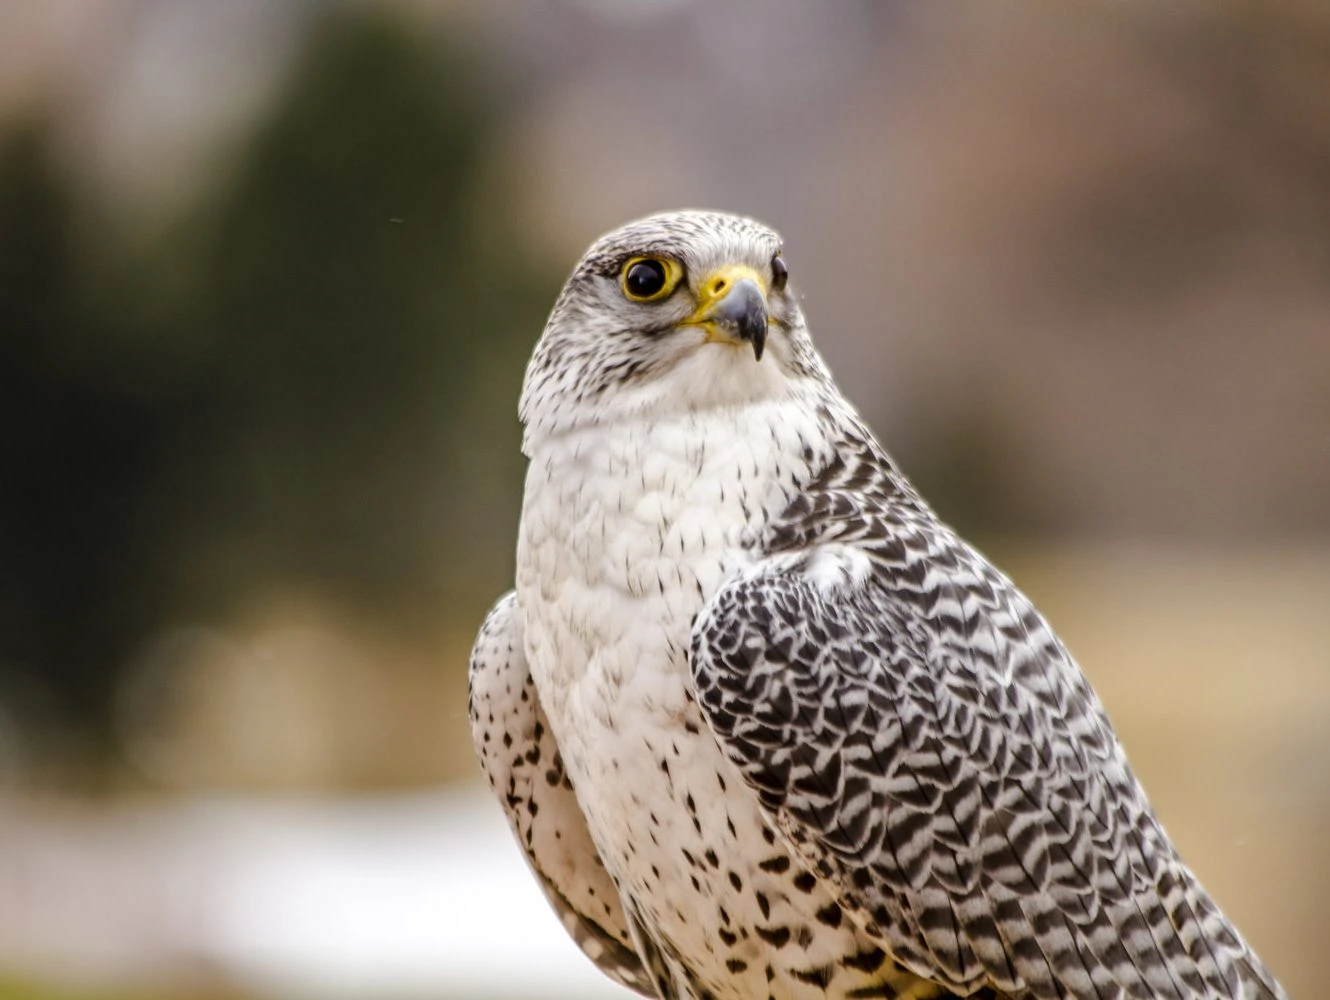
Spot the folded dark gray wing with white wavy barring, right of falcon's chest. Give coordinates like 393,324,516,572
692,449,1285,1000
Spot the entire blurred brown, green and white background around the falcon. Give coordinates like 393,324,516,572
0,0,1330,1000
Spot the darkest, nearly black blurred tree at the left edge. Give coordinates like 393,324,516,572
0,121,179,765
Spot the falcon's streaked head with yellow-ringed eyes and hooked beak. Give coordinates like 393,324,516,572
520,211,826,443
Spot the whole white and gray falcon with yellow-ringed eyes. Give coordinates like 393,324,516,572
469,210,1286,1000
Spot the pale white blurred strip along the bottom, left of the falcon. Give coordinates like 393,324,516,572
0,789,630,1000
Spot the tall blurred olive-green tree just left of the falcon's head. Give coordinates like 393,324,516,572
156,11,549,622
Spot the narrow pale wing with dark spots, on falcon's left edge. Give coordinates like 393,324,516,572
469,592,656,997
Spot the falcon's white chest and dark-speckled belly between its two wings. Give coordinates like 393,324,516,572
517,402,938,997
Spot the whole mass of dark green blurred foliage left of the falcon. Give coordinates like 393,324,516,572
0,9,559,771
